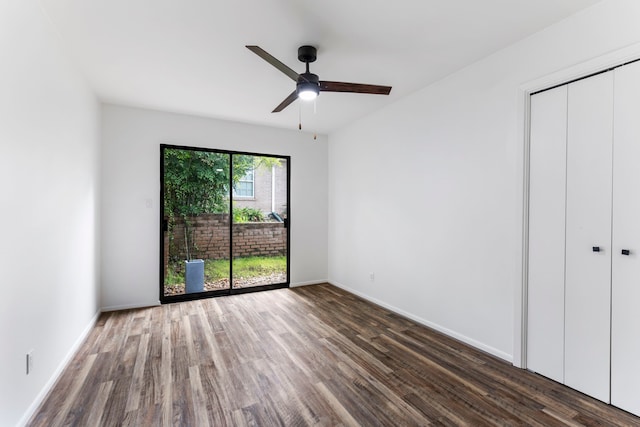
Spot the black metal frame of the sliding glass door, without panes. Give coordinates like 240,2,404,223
158,144,291,304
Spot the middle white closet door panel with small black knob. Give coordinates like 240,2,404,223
564,72,613,402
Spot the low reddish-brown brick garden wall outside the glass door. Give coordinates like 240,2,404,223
165,214,287,265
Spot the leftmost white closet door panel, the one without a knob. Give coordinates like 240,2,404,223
527,85,567,382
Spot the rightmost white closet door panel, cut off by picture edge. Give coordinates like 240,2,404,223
611,63,640,415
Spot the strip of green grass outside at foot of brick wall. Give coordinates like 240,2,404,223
164,256,287,285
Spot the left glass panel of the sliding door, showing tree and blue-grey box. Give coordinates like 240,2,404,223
161,146,231,297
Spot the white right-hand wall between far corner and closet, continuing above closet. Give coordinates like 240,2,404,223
329,0,640,360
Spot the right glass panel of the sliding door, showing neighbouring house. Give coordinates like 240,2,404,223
231,154,288,289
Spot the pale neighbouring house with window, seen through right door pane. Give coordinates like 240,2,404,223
233,159,287,217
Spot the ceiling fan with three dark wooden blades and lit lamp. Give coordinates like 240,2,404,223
246,46,391,113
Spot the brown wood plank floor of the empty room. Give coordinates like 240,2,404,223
29,284,640,426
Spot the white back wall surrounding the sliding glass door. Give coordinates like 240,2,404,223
102,105,327,309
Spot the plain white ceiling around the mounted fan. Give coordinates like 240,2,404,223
40,0,599,133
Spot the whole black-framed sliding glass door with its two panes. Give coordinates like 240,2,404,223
160,145,290,302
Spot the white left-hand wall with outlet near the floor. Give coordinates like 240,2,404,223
0,0,99,426
